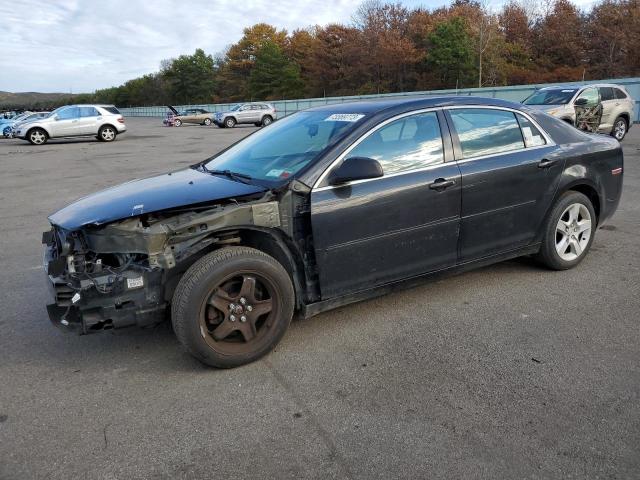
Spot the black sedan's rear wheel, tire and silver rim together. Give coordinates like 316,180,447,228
537,190,597,270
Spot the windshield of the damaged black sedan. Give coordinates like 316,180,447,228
205,111,364,186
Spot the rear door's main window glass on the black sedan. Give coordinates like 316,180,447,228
449,108,524,158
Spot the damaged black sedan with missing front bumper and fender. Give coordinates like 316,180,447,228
43,97,623,367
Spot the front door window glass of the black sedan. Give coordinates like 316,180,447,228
348,112,444,175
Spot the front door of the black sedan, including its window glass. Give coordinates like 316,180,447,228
311,111,460,299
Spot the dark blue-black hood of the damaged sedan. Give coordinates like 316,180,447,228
49,168,266,230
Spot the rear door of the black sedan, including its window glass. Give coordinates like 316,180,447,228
447,107,563,263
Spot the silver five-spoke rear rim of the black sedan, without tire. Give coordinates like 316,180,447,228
555,203,592,261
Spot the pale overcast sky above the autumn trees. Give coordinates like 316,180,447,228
0,0,590,93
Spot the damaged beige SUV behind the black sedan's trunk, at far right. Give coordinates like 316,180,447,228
523,83,636,140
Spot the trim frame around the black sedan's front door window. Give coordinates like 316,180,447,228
313,107,451,192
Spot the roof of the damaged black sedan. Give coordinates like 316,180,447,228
307,95,529,114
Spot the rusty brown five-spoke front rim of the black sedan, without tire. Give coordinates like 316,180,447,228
199,272,278,354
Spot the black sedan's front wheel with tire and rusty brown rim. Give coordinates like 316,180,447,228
171,247,295,368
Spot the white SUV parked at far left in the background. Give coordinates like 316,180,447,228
13,105,127,145
